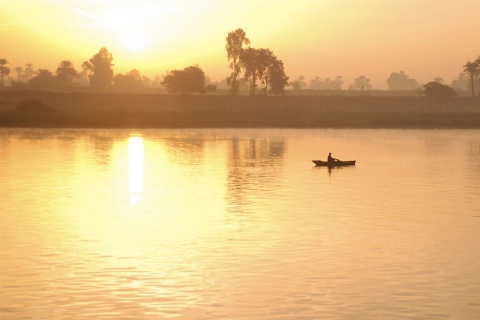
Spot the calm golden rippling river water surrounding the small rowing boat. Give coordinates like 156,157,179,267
0,129,480,320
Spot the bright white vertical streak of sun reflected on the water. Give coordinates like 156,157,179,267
128,135,144,204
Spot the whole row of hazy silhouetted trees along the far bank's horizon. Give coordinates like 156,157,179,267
0,28,480,96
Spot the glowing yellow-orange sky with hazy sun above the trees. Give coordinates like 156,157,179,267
0,0,480,89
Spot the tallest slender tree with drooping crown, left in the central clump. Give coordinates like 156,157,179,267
225,28,250,95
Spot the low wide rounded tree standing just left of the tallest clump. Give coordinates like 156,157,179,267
162,65,205,94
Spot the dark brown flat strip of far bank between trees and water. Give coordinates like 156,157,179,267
0,90,480,128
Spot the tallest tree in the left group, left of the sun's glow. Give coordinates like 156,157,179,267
82,48,113,90
